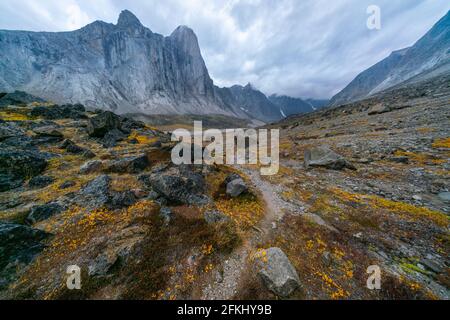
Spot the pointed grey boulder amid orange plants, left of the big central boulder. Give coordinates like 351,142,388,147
73,175,111,209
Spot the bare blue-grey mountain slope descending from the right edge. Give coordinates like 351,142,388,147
331,11,450,106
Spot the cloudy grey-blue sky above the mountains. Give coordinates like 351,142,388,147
0,0,450,99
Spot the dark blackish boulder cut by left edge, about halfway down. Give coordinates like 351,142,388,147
0,148,47,191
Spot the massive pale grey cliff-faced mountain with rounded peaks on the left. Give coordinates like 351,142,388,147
0,10,282,121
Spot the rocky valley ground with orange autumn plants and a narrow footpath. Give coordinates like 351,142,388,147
0,72,450,299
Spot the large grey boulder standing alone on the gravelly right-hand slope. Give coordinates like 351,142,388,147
304,146,356,170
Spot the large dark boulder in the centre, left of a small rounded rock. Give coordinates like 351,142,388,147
149,167,210,205
